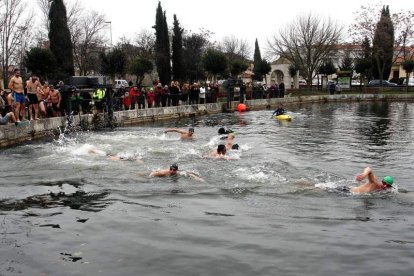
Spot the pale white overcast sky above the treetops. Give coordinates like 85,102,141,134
79,0,392,51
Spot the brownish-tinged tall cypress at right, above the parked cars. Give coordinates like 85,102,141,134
372,6,394,80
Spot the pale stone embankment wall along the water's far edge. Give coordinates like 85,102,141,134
0,94,414,148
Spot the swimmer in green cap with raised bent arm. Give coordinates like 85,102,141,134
351,167,394,194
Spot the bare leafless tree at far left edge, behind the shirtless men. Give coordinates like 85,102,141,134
0,0,33,87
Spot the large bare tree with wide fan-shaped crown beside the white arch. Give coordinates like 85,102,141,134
267,13,342,85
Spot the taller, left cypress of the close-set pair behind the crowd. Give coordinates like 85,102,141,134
154,2,171,84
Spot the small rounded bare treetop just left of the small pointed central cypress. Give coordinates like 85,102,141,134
219,35,252,59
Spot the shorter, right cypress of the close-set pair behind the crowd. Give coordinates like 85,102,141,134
172,14,185,81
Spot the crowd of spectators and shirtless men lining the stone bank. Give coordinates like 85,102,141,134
0,69,285,124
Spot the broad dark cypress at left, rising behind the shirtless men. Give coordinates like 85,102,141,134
49,0,75,81
